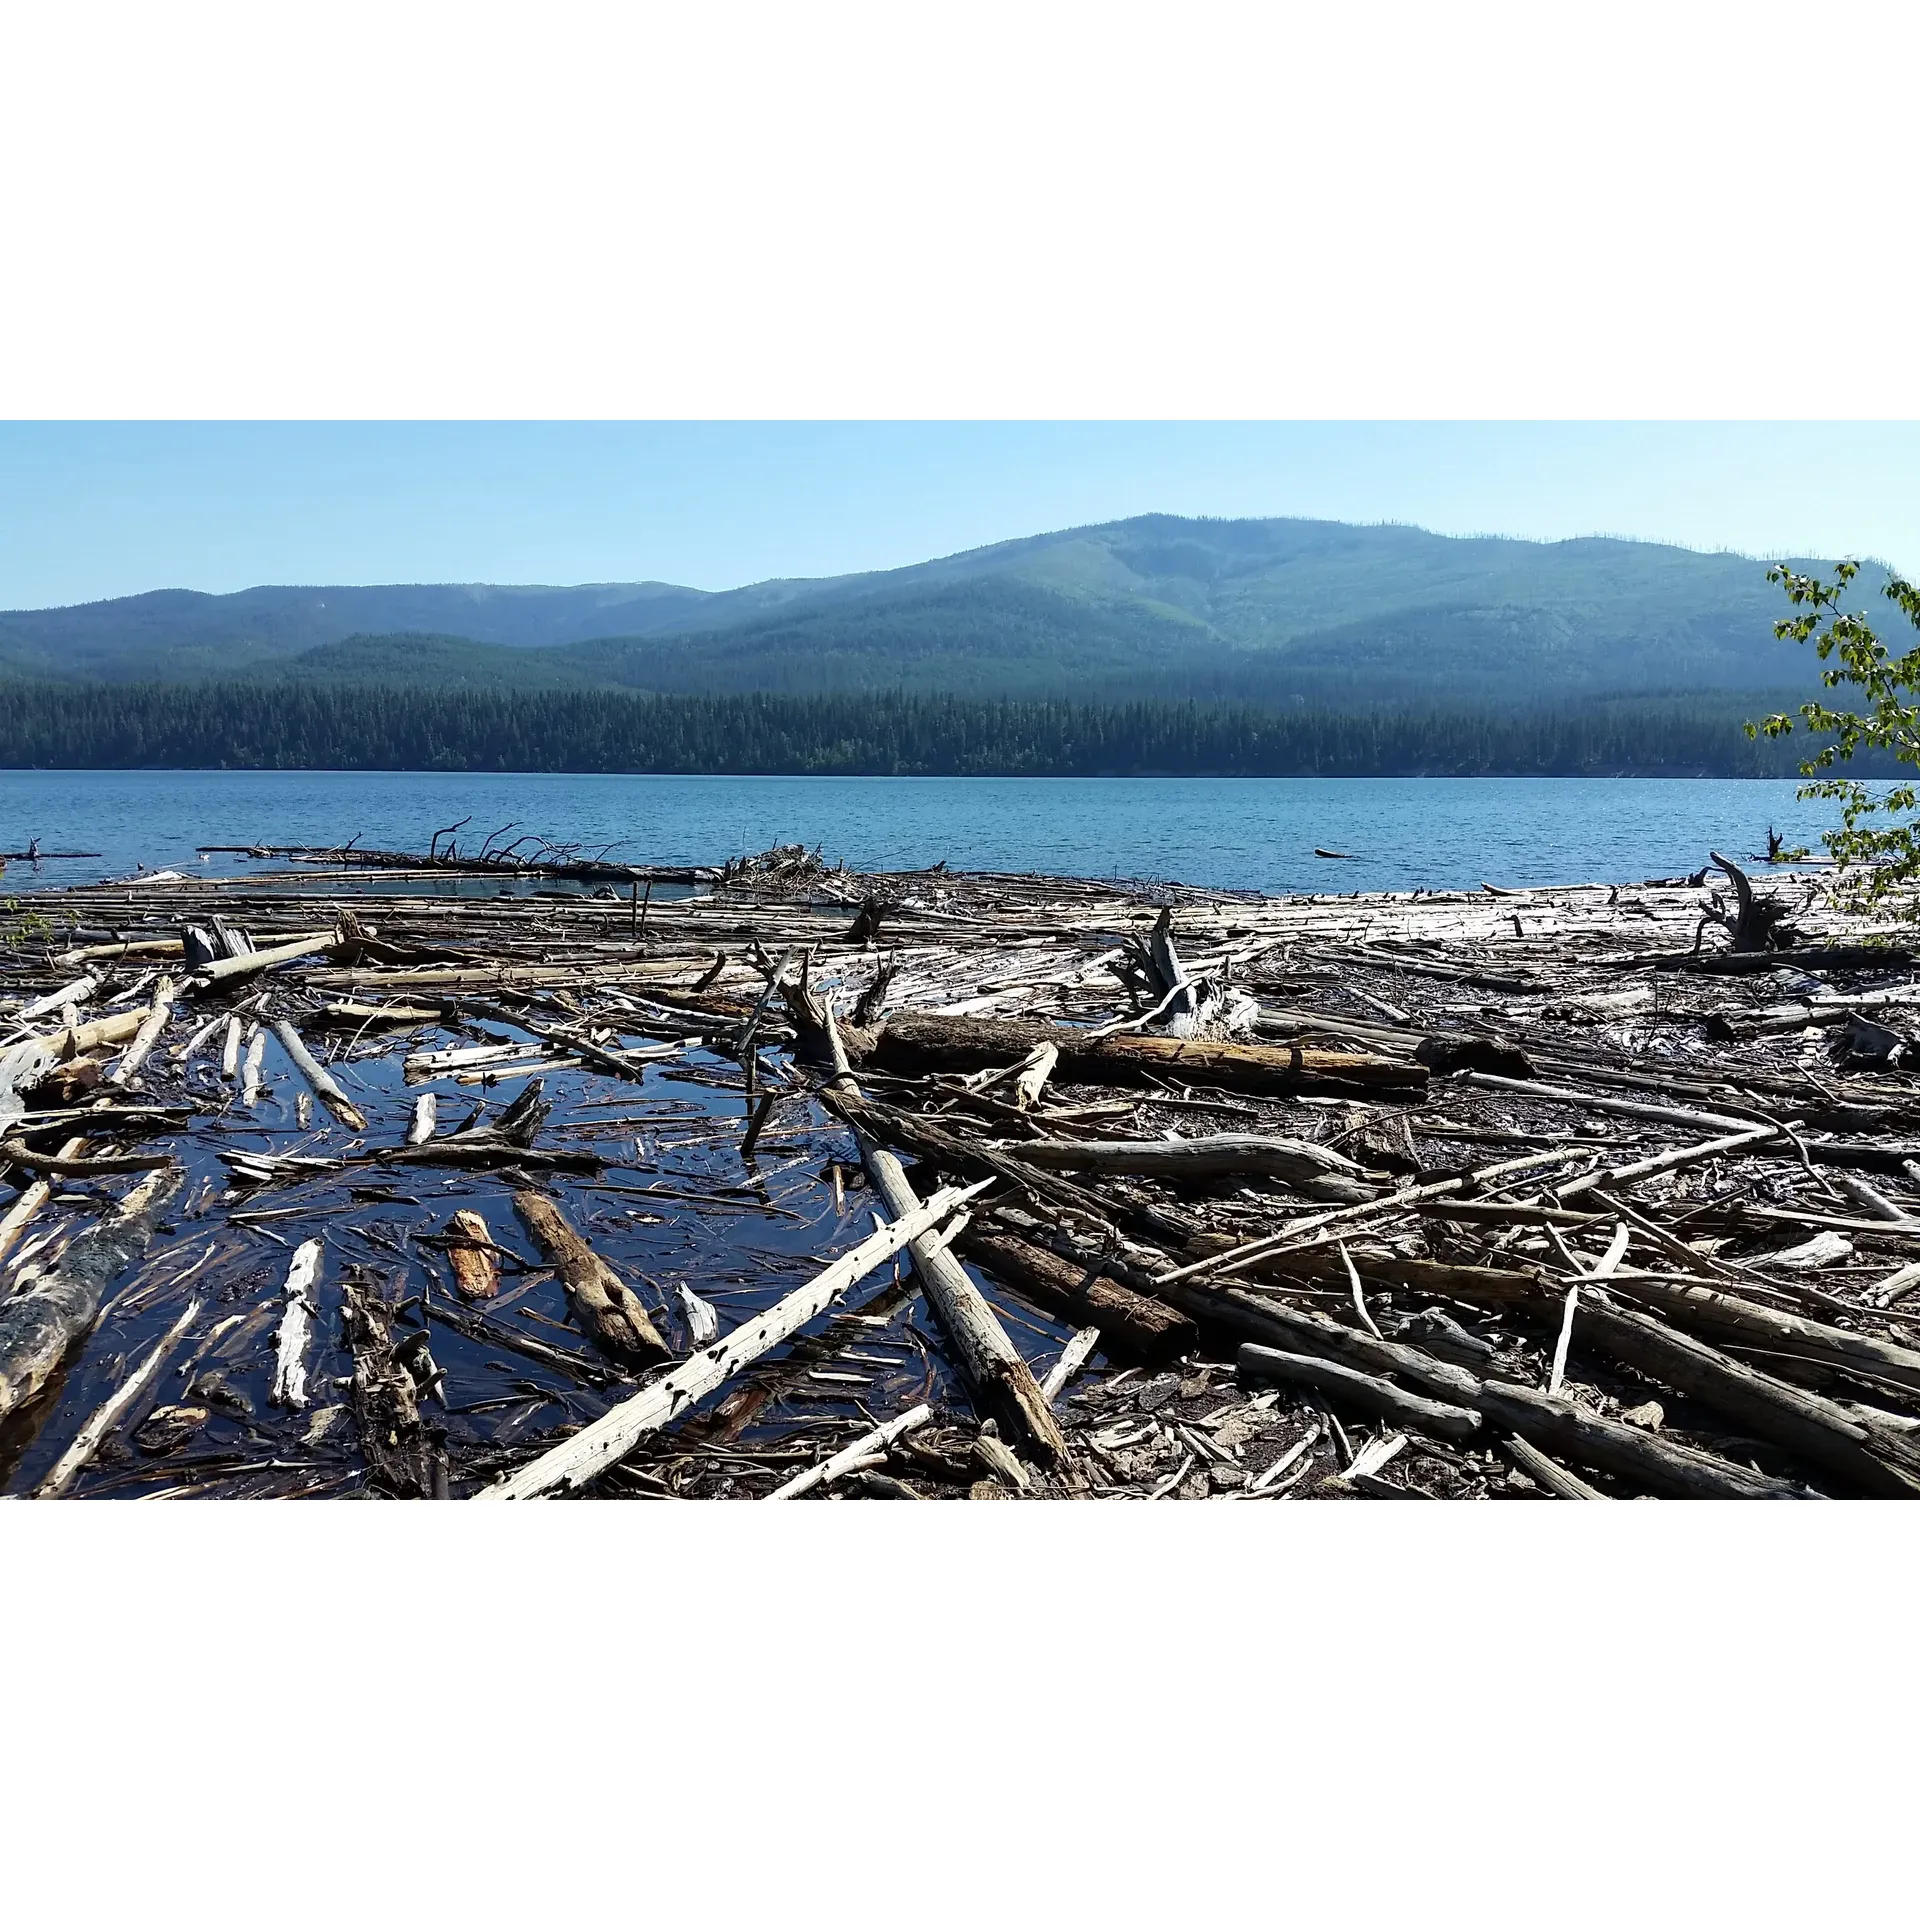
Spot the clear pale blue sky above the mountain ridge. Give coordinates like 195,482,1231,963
0,422,1920,607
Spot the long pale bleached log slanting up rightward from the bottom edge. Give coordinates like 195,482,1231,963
474,1183,985,1500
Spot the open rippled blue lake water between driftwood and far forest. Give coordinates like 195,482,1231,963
0,772,1837,893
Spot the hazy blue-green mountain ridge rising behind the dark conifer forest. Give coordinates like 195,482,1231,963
0,515,1878,705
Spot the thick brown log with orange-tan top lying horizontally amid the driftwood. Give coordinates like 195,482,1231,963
845,1014,1427,1098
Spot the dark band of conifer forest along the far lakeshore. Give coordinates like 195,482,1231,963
0,682,1812,778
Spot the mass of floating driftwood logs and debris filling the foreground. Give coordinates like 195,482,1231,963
0,843,1920,1500
